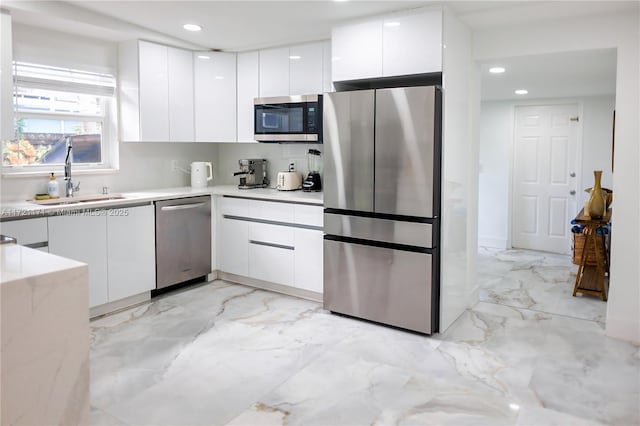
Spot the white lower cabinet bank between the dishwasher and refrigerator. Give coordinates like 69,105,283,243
218,197,323,293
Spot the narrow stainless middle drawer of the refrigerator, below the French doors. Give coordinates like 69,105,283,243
324,213,437,248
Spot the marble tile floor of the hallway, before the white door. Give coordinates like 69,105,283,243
478,247,607,323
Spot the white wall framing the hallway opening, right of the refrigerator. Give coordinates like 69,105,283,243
474,12,640,342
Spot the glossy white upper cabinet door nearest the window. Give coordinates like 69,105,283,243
138,41,169,142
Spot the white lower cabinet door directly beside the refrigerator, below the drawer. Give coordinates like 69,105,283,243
294,229,323,293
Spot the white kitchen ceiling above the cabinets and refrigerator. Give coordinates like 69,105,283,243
3,0,638,51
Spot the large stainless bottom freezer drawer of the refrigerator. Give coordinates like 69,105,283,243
324,239,433,333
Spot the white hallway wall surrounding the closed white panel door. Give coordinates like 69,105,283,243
478,96,615,248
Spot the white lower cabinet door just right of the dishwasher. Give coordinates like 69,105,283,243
218,218,249,277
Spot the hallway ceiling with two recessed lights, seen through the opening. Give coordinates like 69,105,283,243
481,49,616,101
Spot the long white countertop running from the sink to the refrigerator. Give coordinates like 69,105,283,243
0,185,323,219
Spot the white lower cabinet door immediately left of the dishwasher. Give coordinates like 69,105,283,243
107,205,156,302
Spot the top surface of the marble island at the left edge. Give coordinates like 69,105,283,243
0,244,84,285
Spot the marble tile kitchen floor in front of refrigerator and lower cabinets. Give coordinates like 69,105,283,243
91,281,640,426
